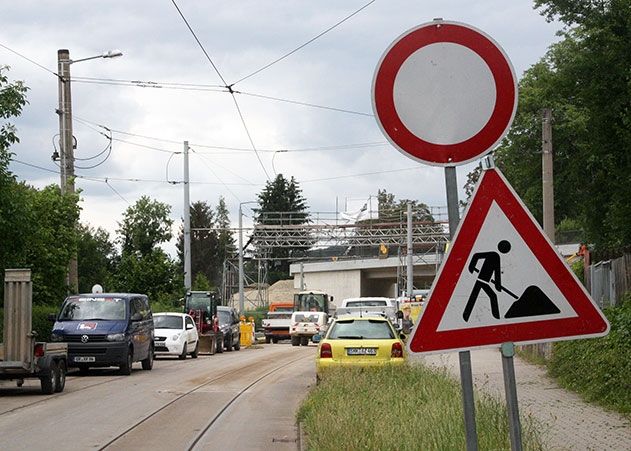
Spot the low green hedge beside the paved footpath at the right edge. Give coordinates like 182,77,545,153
548,293,631,415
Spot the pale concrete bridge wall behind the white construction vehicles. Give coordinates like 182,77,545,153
294,269,361,306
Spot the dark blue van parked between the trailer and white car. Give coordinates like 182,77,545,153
51,293,153,375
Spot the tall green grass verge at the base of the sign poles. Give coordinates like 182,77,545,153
298,365,543,451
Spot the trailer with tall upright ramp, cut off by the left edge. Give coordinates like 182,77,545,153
0,269,68,395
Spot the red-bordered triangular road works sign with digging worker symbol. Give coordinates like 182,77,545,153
408,169,609,353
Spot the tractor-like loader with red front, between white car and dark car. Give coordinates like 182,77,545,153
184,291,223,355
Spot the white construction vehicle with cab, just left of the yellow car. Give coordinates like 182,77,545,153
289,291,336,346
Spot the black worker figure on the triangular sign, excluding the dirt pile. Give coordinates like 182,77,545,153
462,240,511,321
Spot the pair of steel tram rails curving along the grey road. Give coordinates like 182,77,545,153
97,355,313,451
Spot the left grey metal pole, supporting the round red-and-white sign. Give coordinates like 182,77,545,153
445,166,478,451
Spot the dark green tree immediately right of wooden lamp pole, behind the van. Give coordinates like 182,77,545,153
77,224,118,293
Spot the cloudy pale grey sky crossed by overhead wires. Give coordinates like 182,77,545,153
0,0,560,251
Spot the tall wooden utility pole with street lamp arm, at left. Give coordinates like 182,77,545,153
57,49,123,291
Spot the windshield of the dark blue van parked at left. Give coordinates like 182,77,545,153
59,297,126,321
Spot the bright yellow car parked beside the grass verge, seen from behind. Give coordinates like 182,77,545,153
316,316,405,378
